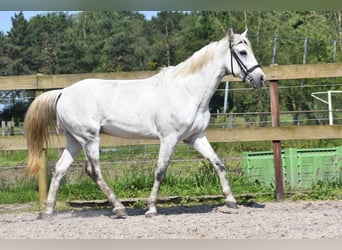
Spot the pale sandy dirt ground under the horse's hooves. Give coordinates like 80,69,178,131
0,201,342,239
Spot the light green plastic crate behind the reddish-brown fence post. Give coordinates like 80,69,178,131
242,147,342,189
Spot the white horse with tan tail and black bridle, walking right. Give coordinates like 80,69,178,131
25,29,266,217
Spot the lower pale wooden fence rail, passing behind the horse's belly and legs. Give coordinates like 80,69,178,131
0,125,342,151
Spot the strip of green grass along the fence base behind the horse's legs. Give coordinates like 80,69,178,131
0,157,342,206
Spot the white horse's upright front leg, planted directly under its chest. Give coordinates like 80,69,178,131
145,138,177,217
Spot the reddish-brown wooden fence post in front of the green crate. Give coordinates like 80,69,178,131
270,80,284,201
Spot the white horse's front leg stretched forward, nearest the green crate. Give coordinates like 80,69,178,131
184,134,237,208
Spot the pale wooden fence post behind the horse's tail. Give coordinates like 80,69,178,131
36,90,47,209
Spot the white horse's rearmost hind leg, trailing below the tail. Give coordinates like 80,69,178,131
41,133,82,218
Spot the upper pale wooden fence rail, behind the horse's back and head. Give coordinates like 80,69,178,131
0,63,342,90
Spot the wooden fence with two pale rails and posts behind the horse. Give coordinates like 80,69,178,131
0,63,342,207
